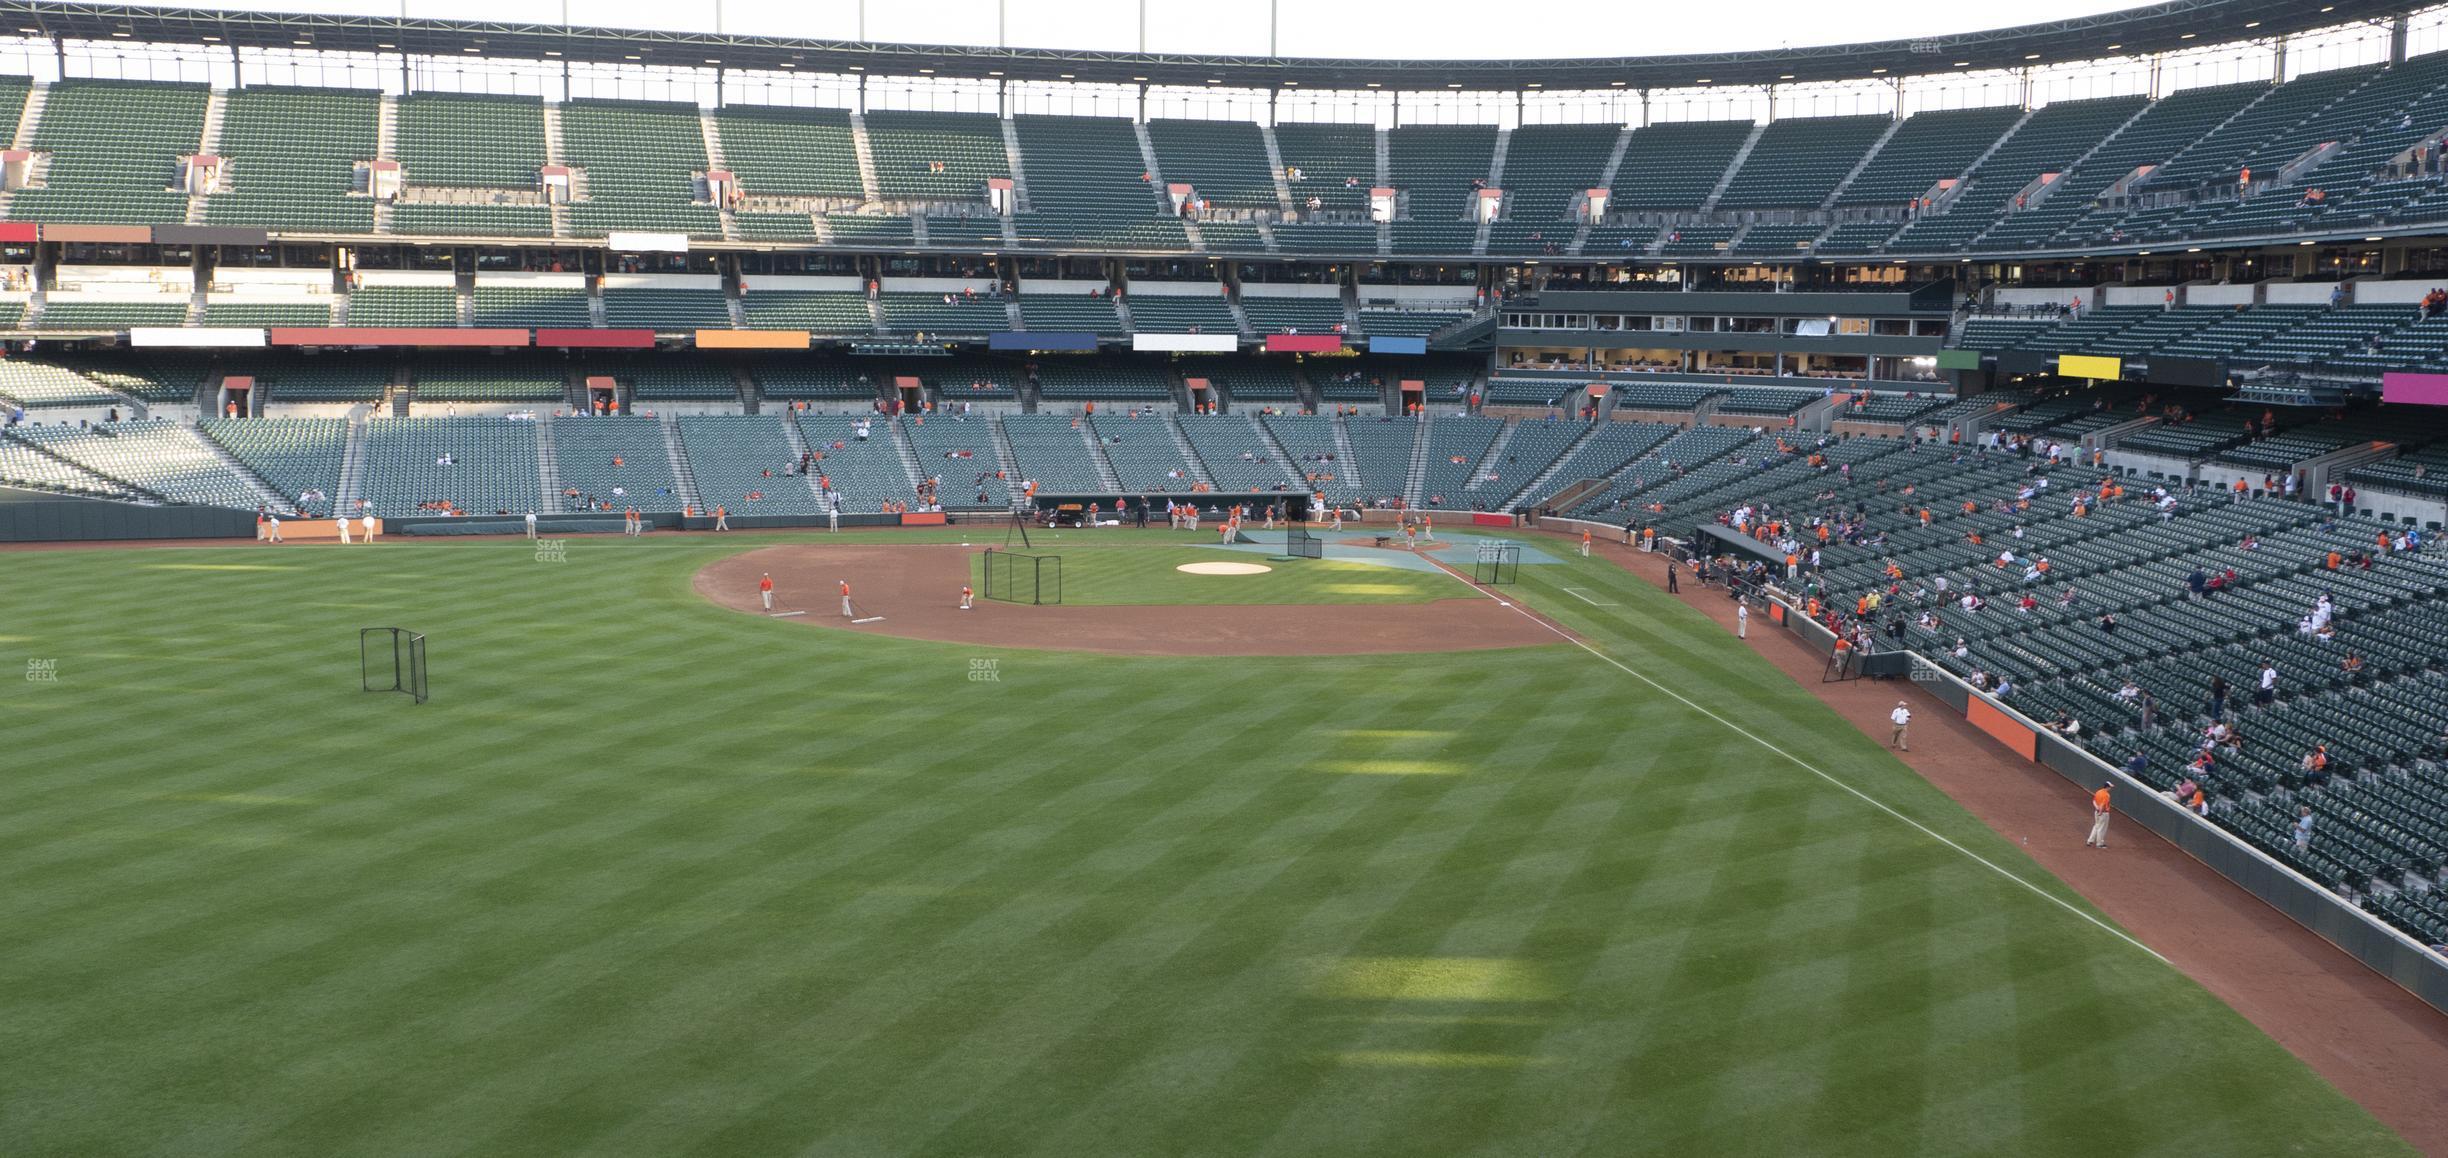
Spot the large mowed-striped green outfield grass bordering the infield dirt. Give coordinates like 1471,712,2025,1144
0,536,2404,1156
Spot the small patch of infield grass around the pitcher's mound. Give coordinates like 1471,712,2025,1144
969,534,1471,607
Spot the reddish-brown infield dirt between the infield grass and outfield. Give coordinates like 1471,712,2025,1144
693,544,1569,656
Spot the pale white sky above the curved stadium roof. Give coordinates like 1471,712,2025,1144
137,0,2140,59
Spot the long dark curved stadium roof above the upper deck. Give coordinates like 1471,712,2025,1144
0,0,2424,91
